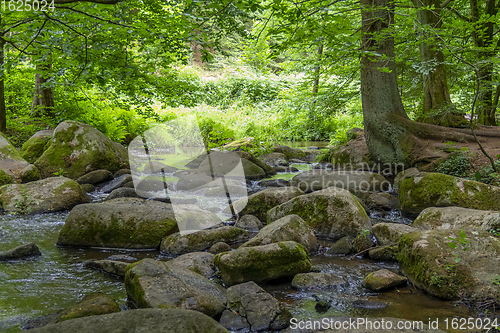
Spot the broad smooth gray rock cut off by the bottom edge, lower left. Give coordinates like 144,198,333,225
23,309,227,333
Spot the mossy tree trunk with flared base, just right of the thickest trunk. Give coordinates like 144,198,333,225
413,0,467,127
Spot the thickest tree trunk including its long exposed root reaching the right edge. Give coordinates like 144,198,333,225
361,0,500,167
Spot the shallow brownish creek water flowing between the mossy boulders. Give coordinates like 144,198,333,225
0,160,498,333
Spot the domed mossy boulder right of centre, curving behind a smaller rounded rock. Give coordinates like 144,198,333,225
267,187,371,240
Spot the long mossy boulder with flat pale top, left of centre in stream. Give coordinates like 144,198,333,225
57,198,178,249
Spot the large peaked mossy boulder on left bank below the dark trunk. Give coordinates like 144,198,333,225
34,121,128,179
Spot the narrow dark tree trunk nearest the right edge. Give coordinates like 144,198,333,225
470,0,498,125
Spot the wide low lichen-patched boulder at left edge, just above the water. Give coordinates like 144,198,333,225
0,177,90,214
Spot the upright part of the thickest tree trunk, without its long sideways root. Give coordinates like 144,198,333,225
361,0,409,164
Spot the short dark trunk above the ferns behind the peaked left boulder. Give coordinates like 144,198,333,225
31,64,54,118
